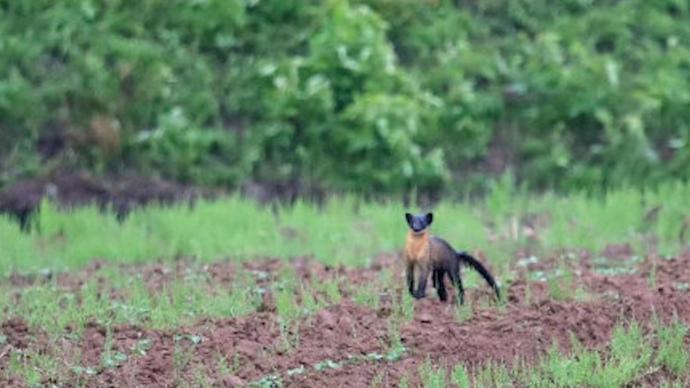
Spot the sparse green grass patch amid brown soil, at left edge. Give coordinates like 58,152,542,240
0,270,259,335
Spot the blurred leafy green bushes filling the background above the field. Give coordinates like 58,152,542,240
0,0,690,193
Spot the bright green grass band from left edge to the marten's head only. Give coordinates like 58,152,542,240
0,197,406,275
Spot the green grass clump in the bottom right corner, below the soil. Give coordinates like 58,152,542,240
440,322,688,388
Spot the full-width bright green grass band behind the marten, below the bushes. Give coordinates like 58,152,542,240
0,183,690,275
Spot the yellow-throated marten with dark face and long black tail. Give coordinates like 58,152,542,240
405,213,500,304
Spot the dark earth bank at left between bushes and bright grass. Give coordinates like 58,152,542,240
0,168,336,230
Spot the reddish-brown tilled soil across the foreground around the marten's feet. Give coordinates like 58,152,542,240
0,252,690,387
